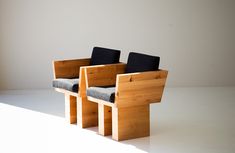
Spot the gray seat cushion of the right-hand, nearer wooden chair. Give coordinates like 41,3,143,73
87,87,115,103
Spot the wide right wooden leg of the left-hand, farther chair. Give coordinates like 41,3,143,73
77,97,98,128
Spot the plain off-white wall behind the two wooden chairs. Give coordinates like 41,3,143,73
0,0,235,89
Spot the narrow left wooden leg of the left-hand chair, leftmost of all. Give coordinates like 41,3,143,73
65,94,77,124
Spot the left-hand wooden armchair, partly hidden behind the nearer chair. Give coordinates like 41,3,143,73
53,47,120,127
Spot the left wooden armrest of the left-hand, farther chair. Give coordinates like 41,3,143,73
53,58,90,79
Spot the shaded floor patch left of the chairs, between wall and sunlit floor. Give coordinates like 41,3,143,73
0,90,64,117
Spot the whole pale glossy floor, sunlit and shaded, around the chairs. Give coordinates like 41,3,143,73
0,87,235,153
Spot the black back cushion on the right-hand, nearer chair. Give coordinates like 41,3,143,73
126,52,160,73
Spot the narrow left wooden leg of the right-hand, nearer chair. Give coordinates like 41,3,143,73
98,104,112,136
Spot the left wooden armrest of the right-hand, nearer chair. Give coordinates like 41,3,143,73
85,63,126,87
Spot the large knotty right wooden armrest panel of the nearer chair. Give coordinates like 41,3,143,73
115,70,168,107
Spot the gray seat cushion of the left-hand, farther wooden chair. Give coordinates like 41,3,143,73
52,78,79,92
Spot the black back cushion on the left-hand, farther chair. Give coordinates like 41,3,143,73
90,47,121,65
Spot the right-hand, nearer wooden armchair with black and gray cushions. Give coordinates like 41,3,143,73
84,52,168,141
